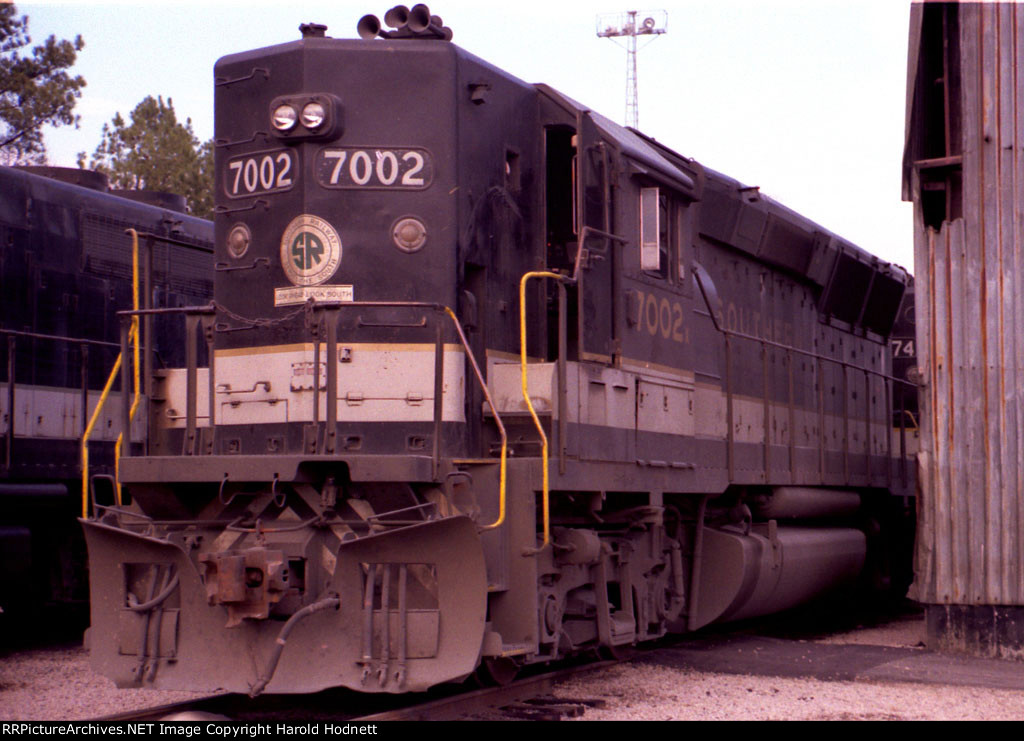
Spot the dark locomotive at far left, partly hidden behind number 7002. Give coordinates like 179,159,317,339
0,167,213,627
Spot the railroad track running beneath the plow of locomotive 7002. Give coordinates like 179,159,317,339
95,658,626,723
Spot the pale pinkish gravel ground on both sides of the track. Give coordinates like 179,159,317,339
0,618,1024,721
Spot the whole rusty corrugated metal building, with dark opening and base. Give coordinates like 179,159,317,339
903,2,1024,657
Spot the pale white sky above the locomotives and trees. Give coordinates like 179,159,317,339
17,0,913,269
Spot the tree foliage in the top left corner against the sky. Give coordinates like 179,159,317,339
0,3,85,162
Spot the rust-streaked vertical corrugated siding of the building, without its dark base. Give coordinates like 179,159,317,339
913,3,1024,605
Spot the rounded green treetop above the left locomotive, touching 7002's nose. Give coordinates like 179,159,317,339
86,95,213,218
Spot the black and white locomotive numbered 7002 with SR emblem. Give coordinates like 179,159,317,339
77,5,913,695
